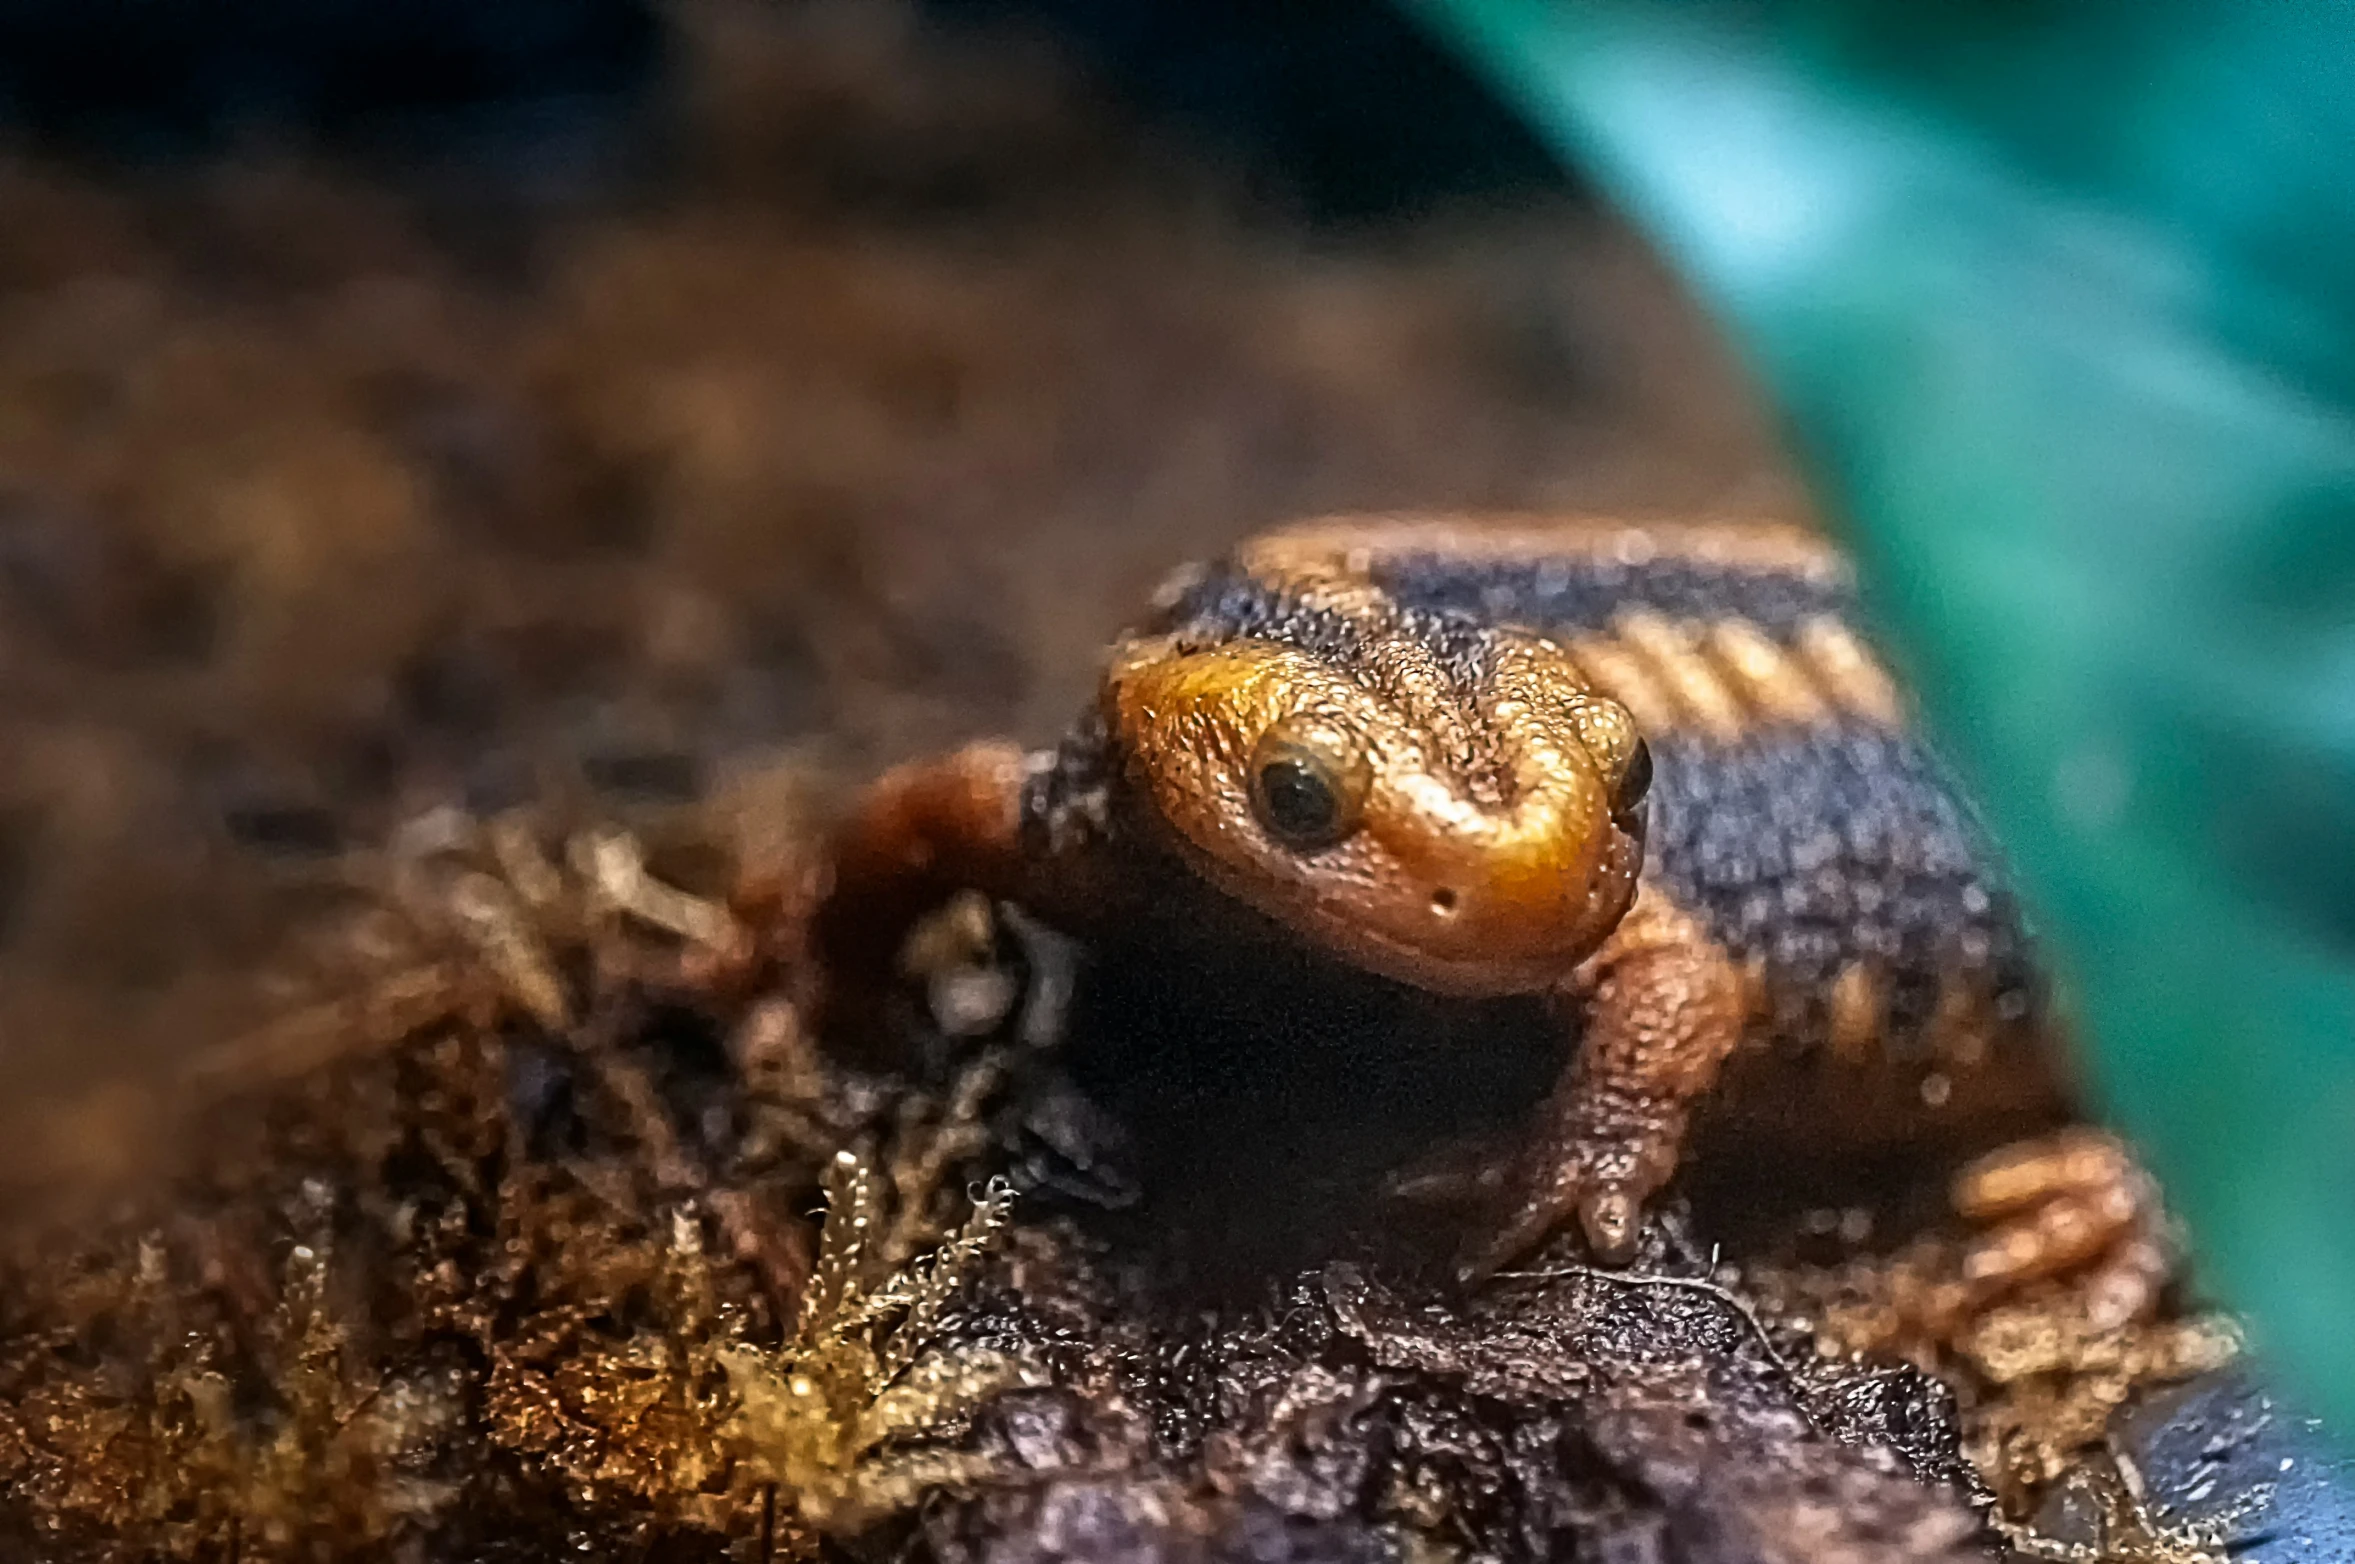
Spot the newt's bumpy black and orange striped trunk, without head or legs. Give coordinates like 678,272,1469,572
1022,525,2051,1116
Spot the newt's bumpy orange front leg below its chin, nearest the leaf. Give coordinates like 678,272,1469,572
1462,886,1745,1279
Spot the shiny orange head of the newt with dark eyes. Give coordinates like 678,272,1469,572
1104,631,1651,994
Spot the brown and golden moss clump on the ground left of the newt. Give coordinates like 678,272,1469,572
0,800,1027,1559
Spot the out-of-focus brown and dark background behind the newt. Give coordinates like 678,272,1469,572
0,0,1799,1125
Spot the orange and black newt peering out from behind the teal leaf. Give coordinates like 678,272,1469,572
820,516,2169,1319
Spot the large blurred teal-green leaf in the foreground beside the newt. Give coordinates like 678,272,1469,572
1406,0,2355,1427
